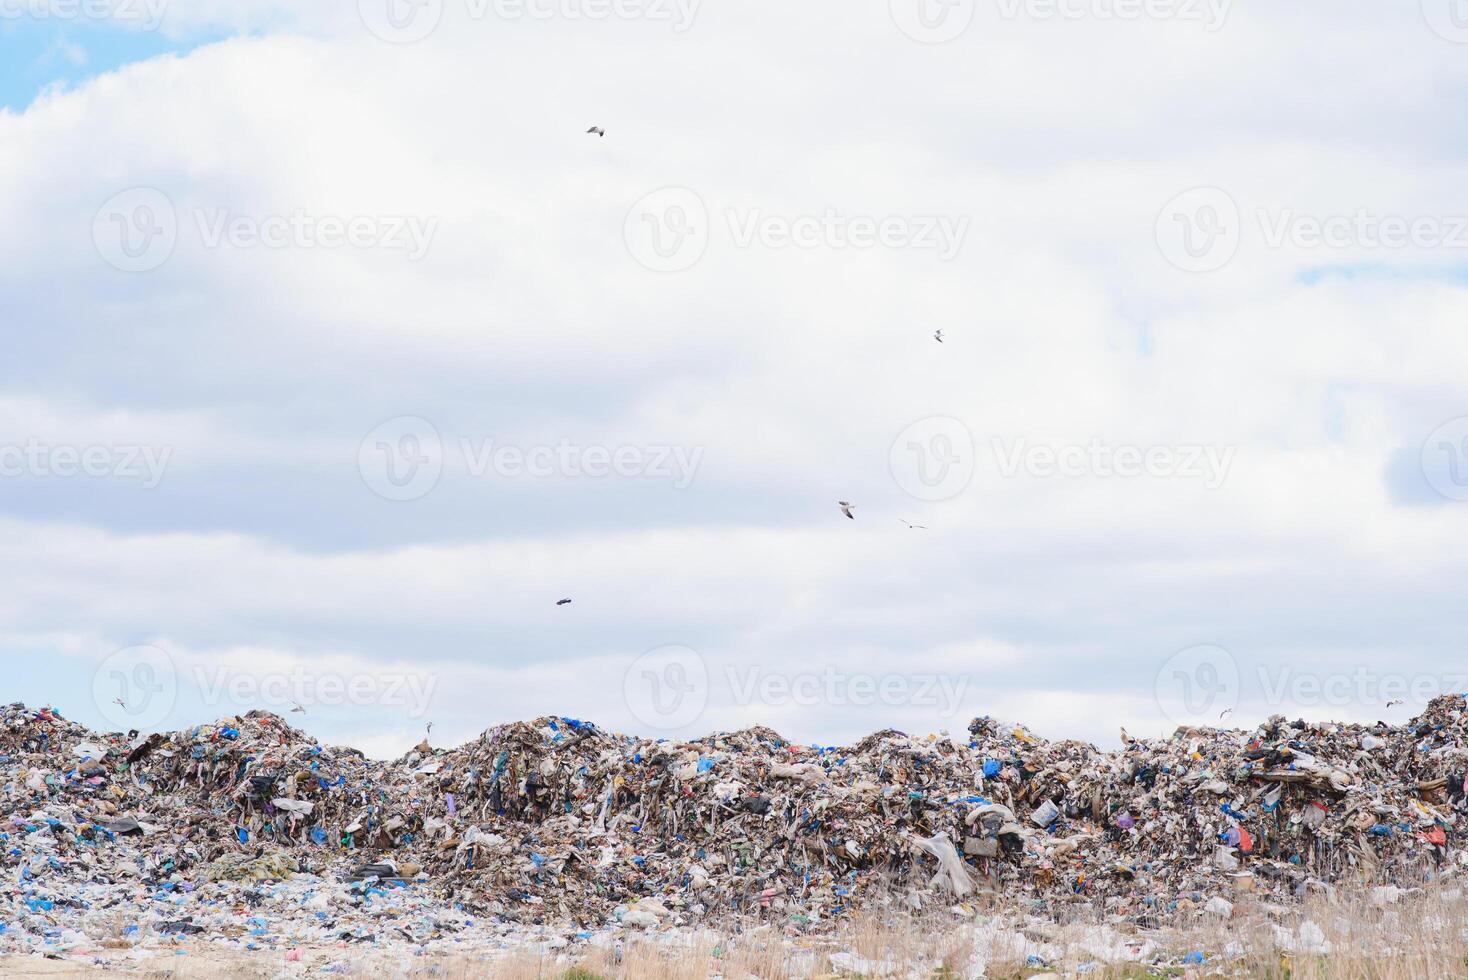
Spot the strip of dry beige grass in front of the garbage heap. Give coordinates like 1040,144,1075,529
0,888,1468,980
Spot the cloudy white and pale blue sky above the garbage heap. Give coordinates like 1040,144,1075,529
0,0,1468,754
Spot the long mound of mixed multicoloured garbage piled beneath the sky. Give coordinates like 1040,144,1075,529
0,697,1468,939
